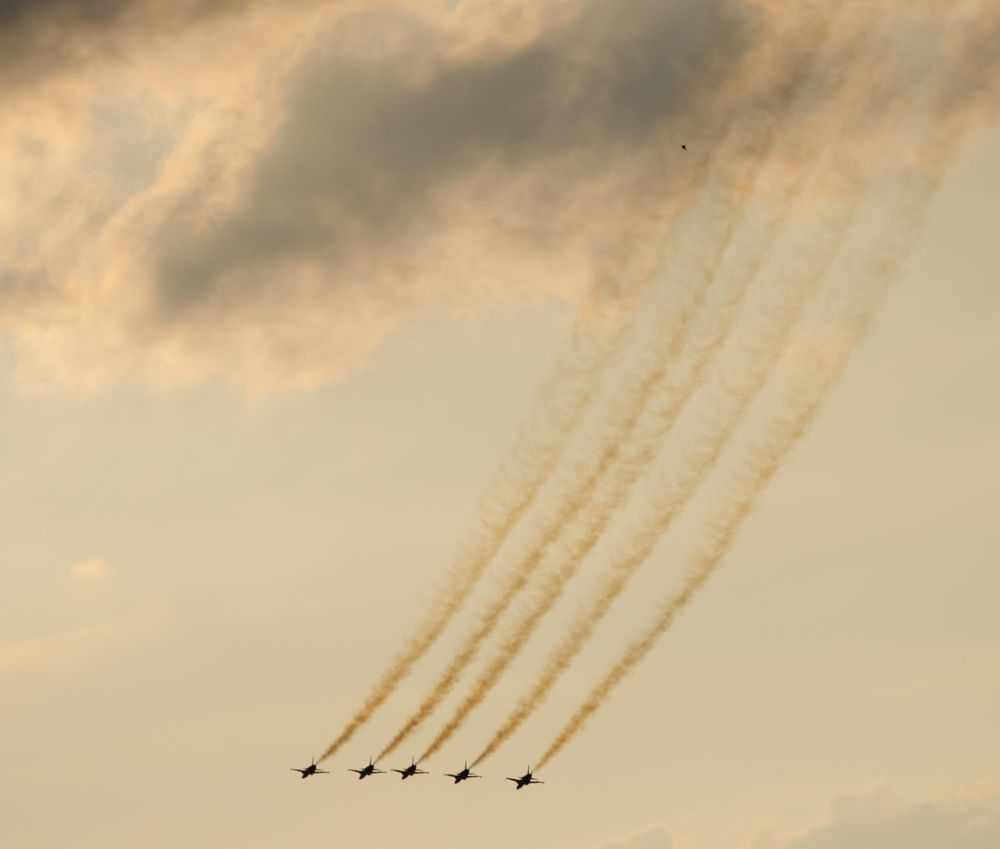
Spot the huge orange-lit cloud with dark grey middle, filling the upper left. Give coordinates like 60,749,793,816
0,0,995,391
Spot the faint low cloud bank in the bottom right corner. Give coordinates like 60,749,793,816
746,788,1000,849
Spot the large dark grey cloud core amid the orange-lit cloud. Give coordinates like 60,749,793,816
146,0,754,320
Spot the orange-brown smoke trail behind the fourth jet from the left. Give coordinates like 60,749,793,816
475,1,920,764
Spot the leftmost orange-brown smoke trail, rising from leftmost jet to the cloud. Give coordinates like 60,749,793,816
320,308,627,763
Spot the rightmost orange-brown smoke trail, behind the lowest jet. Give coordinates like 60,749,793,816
538,26,992,768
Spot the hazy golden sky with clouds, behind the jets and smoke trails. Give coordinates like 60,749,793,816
0,0,1000,849
